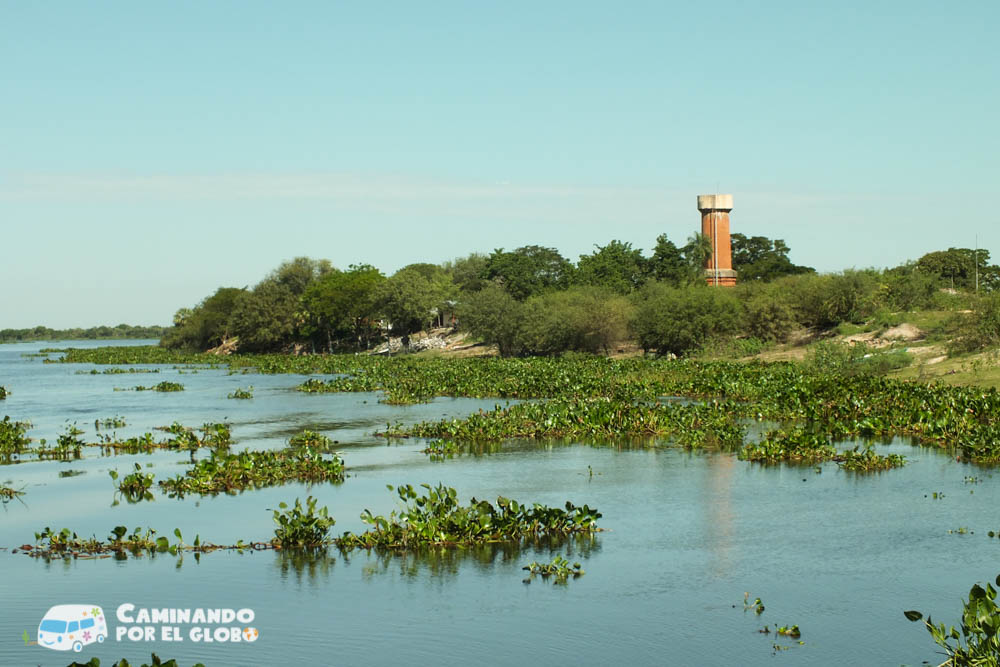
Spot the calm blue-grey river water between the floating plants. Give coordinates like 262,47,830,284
0,342,1000,667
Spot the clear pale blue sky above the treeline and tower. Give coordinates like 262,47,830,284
0,0,1000,328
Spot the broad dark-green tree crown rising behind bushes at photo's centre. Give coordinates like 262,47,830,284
486,245,573,301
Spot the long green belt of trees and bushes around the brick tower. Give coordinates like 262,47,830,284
160,234,1000,356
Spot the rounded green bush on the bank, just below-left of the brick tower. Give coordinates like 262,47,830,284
632,283,740,355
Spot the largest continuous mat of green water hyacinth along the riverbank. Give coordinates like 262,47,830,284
39,346,1000,471
